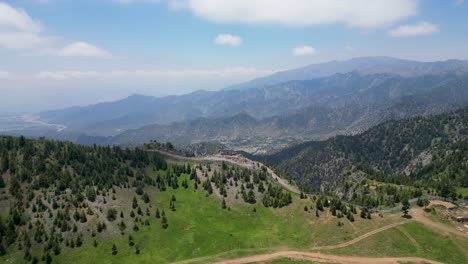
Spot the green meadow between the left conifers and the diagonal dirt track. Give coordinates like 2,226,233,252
1,167,395,263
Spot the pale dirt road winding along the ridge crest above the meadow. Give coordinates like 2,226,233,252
148,149,300,194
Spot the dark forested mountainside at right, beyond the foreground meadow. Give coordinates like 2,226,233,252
259,108,468,195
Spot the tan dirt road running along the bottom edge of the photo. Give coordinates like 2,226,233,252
215,251,441,264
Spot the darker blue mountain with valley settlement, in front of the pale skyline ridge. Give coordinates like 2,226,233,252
111,73,468,152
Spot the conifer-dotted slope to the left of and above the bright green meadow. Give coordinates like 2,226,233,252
0,137,292,263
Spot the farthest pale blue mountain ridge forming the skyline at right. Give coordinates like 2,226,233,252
227,57,468,90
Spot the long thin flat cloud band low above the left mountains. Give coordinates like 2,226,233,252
34,67,274,81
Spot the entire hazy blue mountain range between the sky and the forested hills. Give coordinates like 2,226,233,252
5,57,468,153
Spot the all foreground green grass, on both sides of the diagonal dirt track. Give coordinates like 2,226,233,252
3,168,468,263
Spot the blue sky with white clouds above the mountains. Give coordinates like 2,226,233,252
0,0,468,114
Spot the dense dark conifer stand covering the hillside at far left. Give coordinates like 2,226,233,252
0,137,167,261
